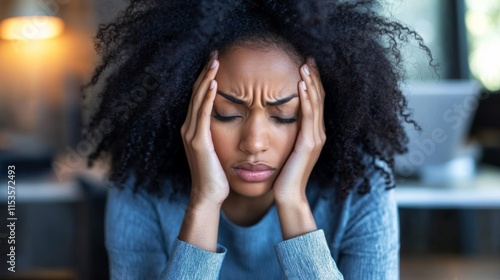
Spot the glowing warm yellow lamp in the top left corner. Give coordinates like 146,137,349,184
0,0,64,40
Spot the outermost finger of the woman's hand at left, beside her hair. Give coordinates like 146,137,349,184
186,59,219,139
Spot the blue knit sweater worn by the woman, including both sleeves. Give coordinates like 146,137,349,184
106,161,399,280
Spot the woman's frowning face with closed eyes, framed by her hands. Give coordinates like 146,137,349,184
210,46,301,197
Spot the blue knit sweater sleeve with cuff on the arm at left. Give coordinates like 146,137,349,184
105,183,226,280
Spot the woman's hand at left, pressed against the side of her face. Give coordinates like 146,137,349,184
181,52,229,207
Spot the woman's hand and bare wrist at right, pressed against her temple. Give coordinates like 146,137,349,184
273,58,326,239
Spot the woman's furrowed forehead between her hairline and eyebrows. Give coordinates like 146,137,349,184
216,46,301,95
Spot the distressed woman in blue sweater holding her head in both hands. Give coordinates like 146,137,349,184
86,0,430,279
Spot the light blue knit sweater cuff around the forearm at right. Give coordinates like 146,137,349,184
275,230,344,280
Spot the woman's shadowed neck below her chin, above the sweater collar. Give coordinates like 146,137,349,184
222,190,274,226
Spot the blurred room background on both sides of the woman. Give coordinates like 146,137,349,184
0,0,500,280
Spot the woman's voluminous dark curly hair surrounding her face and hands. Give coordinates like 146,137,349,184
84,0,433,201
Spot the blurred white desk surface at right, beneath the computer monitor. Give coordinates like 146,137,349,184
395,167,500,209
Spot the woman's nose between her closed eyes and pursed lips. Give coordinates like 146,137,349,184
239,116,270,155
